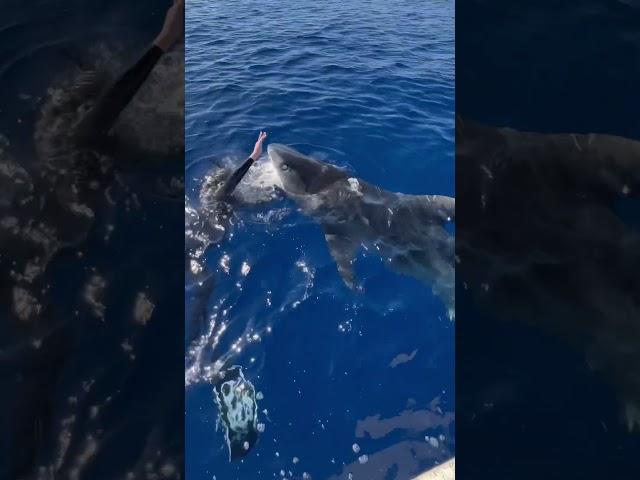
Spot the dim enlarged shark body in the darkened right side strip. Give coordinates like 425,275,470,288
456,117,640,430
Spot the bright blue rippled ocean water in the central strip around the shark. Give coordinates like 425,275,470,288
185,0,455,480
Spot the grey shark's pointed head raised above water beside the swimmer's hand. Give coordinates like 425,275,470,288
267,143,347,195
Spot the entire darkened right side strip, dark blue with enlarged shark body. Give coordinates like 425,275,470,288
456,0,640,480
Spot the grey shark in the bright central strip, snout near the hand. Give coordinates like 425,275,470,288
267,144,455,319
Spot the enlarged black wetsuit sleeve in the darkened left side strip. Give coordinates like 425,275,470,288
77,45,164,140
